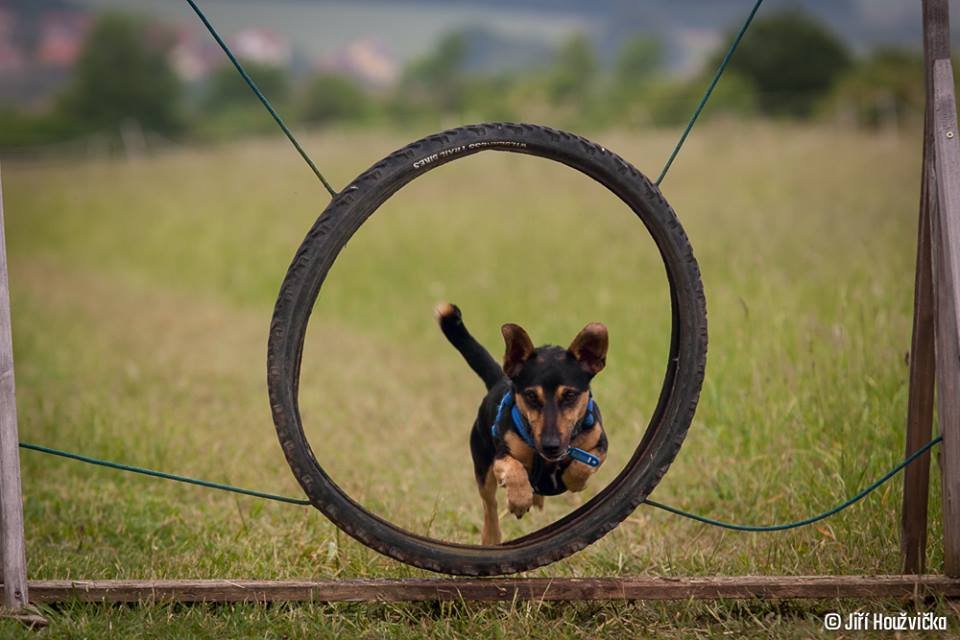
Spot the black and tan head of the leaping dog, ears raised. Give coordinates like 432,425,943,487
501,322,609,461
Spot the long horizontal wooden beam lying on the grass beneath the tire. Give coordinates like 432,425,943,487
13,575,960,603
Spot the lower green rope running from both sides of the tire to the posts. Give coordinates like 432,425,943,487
20,436,943,531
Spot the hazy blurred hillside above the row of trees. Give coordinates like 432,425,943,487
73,0,960,72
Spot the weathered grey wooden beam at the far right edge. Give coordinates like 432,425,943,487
931,59,960,577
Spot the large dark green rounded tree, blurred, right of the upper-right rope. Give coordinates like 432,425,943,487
710,9,851,116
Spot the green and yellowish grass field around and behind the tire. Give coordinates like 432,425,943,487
0,123,953,638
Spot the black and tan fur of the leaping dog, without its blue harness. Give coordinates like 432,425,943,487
436,303,608,544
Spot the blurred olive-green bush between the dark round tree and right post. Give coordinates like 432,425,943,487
826,48,926,127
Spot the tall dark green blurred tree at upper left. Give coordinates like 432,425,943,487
59,13,182,133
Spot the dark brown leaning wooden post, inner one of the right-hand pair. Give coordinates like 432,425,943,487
900,1,947,574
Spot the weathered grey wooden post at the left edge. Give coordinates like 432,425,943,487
0,166,29,611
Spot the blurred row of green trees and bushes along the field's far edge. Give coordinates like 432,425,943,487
0,10,924,147
